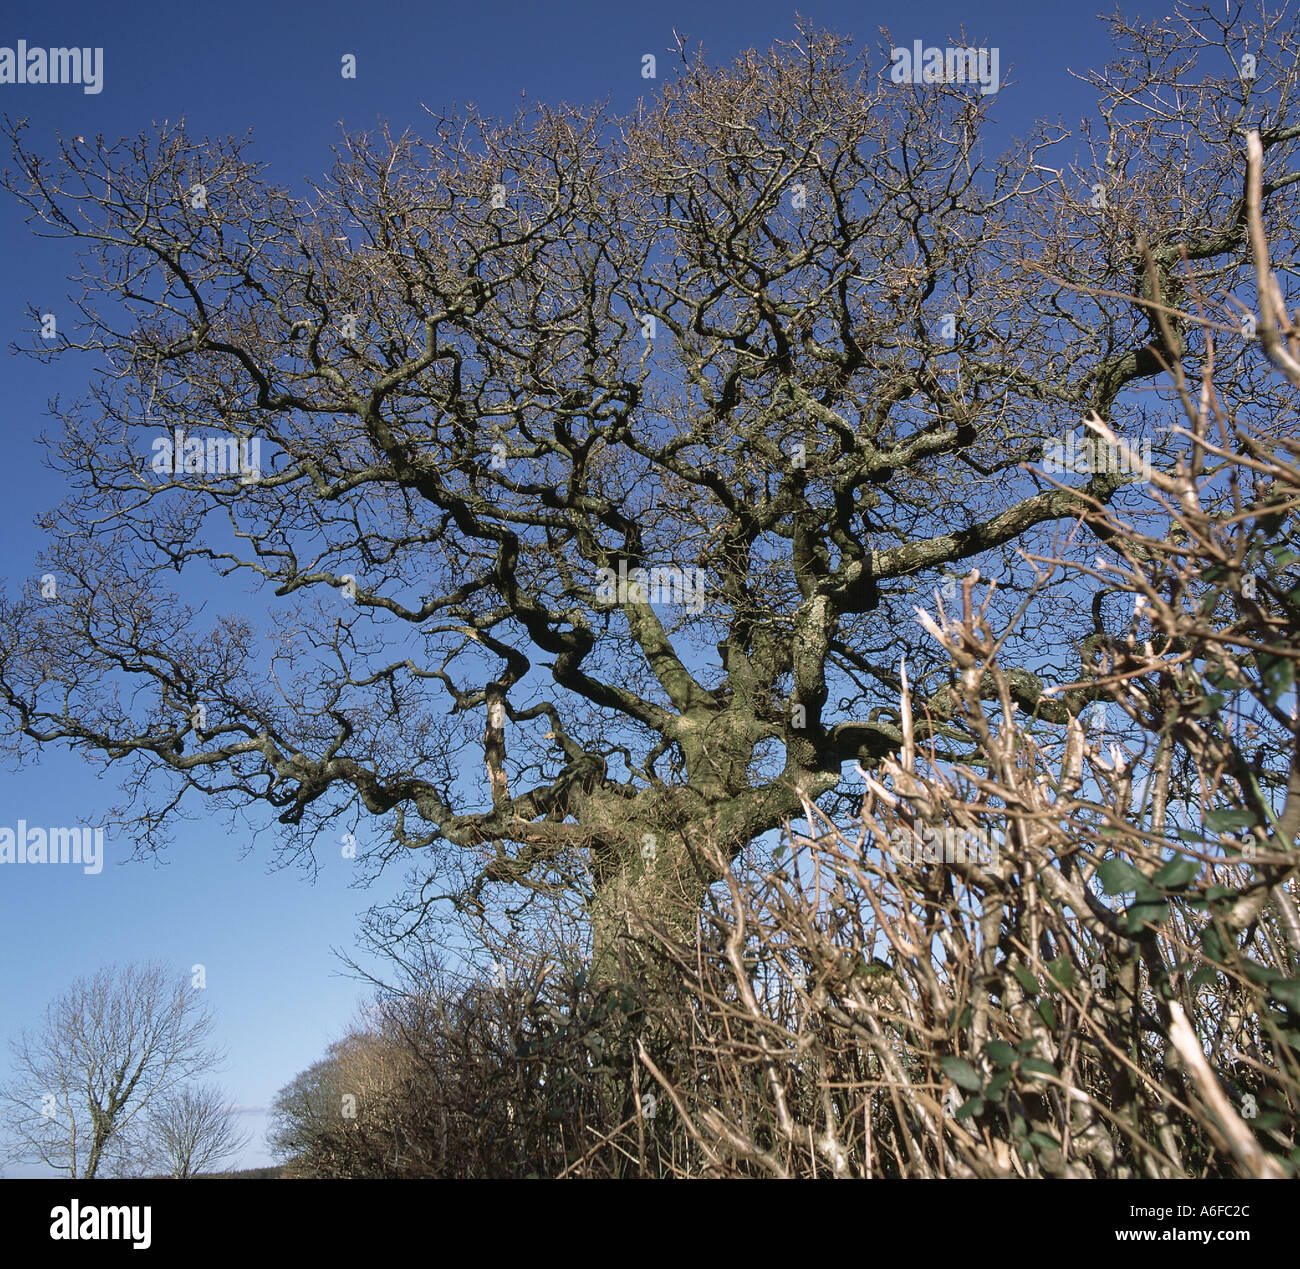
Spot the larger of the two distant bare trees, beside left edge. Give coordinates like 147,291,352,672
0,963,220,1179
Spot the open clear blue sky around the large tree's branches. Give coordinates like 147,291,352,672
0,0,1118,1175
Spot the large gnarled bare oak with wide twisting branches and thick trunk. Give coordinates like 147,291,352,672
0,7,1300,973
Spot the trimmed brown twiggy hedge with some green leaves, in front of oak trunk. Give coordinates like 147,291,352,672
271,151,1300,1178
